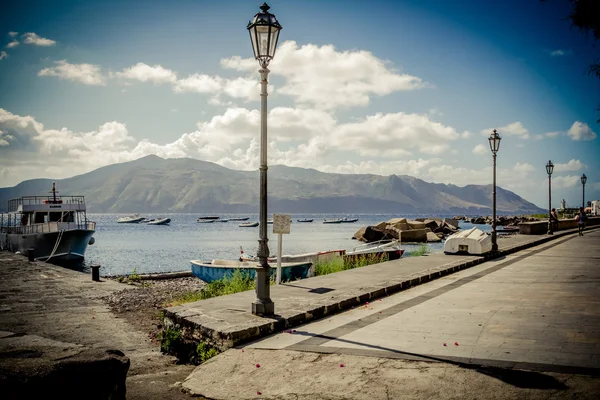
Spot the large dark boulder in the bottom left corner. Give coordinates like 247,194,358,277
0,332,129,400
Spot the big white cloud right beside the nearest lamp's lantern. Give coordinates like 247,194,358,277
221,41,426,110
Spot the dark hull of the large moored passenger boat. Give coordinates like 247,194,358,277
8,229,95,264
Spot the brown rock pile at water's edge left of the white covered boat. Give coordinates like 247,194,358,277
352,218,459,243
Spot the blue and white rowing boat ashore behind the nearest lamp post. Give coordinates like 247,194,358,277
190,260,312,283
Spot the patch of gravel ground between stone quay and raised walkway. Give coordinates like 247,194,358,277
103,277,206,343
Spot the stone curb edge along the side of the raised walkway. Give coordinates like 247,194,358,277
164,227,598,351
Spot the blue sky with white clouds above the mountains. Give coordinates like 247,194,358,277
0,0,600,208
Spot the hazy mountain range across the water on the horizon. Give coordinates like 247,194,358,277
0,155,543,214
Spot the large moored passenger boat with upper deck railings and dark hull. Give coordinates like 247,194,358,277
0,182,96,264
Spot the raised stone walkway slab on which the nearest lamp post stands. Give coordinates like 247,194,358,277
165,225,600,350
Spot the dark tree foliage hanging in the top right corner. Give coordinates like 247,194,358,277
541,0,600,123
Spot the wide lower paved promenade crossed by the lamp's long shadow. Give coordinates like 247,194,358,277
183,229,600,399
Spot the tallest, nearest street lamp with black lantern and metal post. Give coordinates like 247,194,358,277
248,3,282,316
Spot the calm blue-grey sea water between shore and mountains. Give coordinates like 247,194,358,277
85,214,491,275
